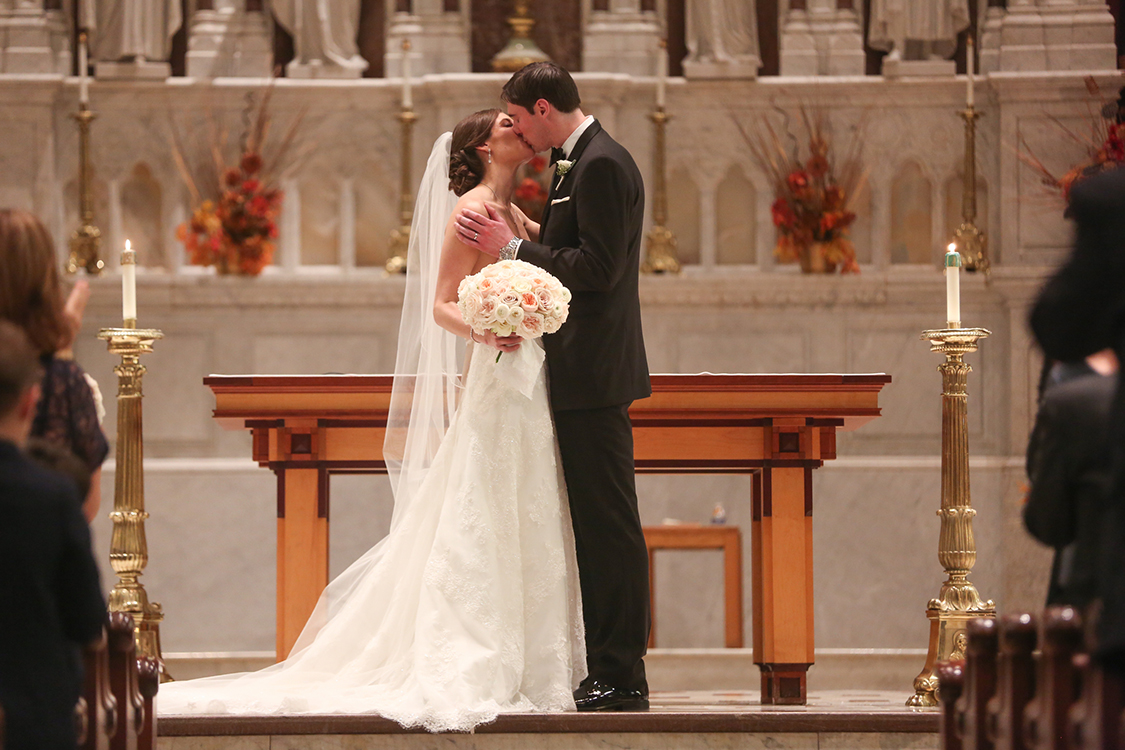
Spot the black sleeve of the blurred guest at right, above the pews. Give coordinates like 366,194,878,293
1024,399,1076,548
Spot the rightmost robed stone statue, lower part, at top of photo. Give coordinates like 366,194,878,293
867,0,969,60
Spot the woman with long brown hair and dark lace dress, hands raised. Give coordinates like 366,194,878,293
0,209,109,521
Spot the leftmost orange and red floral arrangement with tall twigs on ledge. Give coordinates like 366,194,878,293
172,89,304,275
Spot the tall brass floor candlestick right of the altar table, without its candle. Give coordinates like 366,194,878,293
907,328,996,708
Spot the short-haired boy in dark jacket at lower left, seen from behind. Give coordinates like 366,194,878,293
0,320,106,750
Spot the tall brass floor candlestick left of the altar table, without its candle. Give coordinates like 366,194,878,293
98,319,171,680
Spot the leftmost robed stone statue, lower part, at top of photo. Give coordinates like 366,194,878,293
82,0,183,64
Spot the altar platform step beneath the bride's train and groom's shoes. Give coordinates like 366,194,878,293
156,690,939,750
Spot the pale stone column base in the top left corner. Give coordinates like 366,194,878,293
0,0,71,75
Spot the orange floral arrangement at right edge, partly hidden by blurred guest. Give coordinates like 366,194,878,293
1018,75,1125,205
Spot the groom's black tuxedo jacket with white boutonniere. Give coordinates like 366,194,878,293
519,120,651,412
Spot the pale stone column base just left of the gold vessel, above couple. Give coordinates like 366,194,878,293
384,0,473,78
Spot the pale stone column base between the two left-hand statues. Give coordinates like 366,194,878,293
187,0,273,78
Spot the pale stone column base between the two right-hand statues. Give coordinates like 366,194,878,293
781,0,867,75
